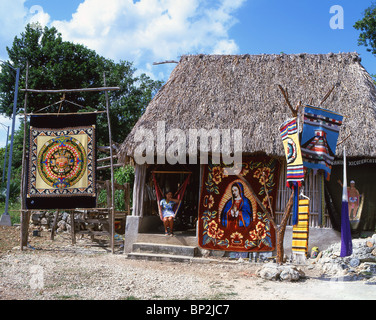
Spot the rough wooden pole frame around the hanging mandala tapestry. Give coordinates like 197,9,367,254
20,62,120,253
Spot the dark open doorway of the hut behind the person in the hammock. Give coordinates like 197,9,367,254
142,164,200,235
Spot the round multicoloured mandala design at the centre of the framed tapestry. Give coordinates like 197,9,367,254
38,136,86,189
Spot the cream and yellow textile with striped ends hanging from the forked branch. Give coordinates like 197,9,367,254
279,118,304,188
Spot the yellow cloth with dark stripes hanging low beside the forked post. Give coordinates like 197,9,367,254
292,199,309,256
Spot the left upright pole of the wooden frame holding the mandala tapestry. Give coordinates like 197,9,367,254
20,61,30,250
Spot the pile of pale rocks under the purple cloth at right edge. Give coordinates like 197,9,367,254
313,234,376,283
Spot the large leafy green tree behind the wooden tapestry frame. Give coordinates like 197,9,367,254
0,24,162,145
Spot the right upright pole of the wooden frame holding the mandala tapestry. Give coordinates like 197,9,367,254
103,72,115,253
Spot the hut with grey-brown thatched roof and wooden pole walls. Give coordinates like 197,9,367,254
120,53,376,255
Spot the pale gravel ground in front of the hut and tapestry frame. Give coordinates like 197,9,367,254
0,227,376,300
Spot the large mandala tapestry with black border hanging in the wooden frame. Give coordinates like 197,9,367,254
26,114,96,209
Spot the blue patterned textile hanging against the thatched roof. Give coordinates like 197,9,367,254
301,105,343,180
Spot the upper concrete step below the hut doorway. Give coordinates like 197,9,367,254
132,242,198,257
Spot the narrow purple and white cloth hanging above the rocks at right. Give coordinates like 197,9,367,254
340,147,352,257
